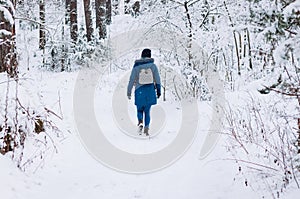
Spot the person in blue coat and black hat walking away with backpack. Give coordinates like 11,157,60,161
127,48,161,136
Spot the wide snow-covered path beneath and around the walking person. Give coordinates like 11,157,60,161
1,19,256,199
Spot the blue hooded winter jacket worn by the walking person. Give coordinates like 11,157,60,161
127,58,161,106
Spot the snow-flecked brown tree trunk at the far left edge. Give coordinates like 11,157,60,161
0,1,18,77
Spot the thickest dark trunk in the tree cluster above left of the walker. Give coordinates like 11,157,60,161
95,0,106,39
